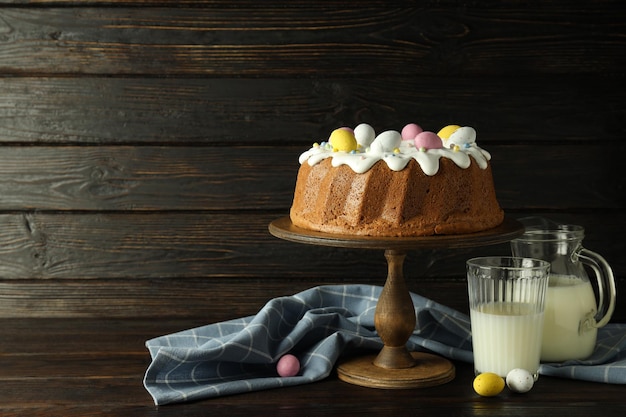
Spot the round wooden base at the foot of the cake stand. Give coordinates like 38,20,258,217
337,352,455,389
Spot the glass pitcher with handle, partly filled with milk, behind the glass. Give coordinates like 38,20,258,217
511,219,616,362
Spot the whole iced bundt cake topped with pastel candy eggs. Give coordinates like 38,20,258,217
290,123,504,237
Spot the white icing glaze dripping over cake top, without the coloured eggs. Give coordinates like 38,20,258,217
299,124,491,176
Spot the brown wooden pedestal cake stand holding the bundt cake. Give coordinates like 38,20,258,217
269,217,524,389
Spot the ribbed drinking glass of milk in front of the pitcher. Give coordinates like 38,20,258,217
467,256,550,379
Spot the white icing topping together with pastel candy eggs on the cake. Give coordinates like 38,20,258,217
299,123,491,176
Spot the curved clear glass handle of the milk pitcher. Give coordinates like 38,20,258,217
573,247,617,328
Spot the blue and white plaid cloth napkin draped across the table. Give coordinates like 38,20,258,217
144,285,626,405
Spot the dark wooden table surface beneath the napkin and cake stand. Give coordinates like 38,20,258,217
0,318,626,417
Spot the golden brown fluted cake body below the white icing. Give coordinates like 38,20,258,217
290,159,504,237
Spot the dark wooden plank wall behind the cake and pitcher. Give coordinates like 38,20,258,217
0,0,626,321
